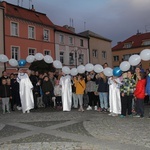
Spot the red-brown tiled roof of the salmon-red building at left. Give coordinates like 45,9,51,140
1,1,54,27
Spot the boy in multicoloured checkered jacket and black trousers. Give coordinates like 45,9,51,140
120,70,136,118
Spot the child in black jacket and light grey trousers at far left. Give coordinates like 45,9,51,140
0,79,12,114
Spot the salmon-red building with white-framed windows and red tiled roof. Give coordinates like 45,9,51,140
1,2,55,72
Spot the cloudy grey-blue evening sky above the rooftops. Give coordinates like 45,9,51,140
5,0,150,46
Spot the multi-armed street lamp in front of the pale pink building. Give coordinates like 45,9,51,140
70,48,83,68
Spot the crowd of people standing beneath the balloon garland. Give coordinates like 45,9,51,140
0,64,150,118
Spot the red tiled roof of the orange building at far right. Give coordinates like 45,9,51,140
112,32,150,51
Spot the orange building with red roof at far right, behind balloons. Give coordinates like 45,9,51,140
112,32,150,69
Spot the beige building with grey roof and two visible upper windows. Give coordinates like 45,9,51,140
79,30,112,67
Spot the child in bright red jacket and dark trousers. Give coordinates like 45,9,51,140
134,72,146,118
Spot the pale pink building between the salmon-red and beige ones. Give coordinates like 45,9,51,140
55,26,89,68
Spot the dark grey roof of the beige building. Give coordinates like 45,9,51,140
79,30,111,42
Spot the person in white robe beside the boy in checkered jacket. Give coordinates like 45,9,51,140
108,76,121,116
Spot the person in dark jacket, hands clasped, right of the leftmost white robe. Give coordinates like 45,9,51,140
42,76,54,108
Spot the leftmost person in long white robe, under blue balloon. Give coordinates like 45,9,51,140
17,70,34,113
